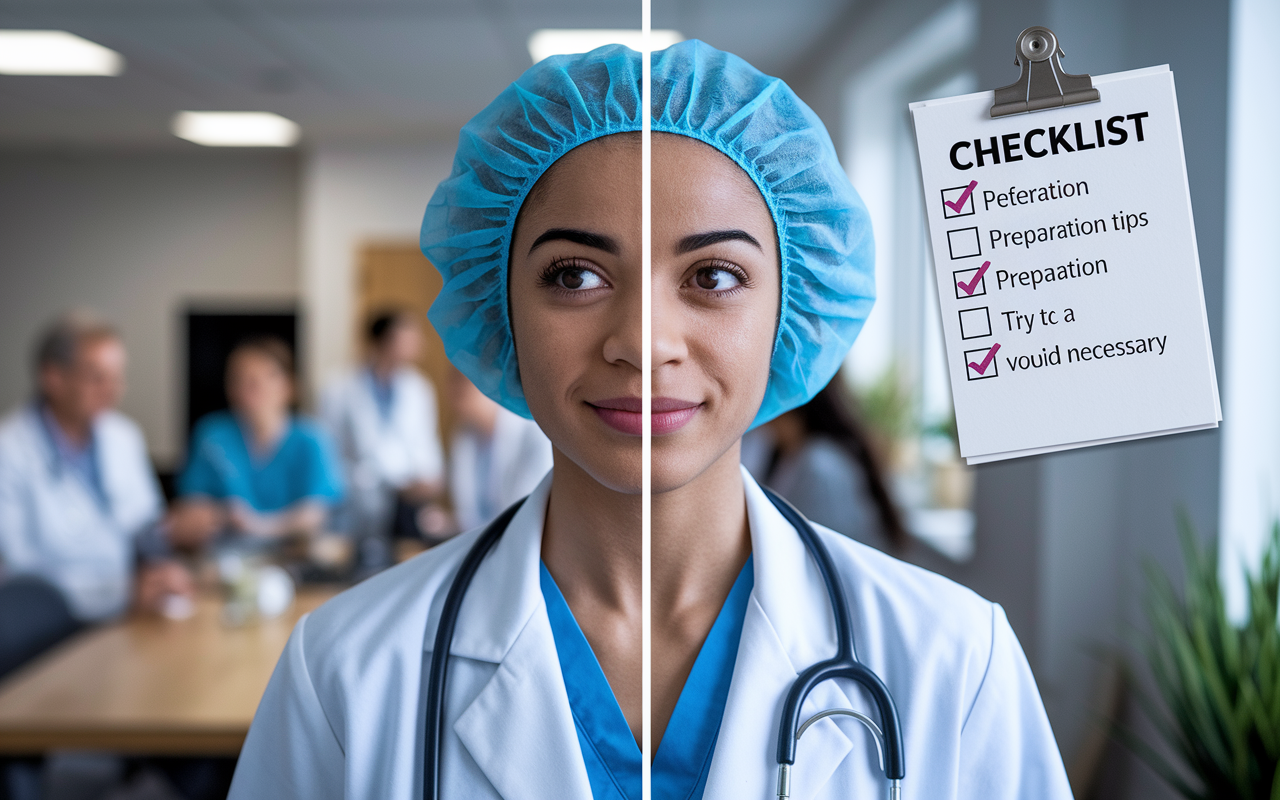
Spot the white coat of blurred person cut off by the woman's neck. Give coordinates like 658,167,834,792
449,408,552,530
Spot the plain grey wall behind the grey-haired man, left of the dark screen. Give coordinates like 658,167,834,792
0,151,298,465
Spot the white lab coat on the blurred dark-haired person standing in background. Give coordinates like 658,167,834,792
320,367,444,530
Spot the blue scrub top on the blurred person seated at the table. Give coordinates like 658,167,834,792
178,411,342,512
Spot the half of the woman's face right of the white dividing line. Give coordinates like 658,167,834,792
653,133,781,493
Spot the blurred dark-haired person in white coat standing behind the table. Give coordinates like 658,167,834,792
320,308,444,566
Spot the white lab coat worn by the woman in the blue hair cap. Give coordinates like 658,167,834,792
230,471,1070,800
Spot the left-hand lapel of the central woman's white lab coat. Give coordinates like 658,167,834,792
453,475,591,800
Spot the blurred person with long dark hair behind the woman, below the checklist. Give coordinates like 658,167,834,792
742,374,909,553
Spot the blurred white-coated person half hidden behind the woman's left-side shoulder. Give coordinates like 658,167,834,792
449,369,552,530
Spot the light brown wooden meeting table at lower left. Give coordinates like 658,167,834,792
0,589,337,755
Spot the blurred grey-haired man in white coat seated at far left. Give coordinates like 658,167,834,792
0,314,192,622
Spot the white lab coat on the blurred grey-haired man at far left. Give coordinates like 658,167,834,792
0,404,163,621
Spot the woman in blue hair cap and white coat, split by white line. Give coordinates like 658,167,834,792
232,41,1070,800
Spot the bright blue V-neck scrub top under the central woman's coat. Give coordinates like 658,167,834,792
541,557,755,800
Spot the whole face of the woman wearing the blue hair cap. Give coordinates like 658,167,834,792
509,134,780,492
